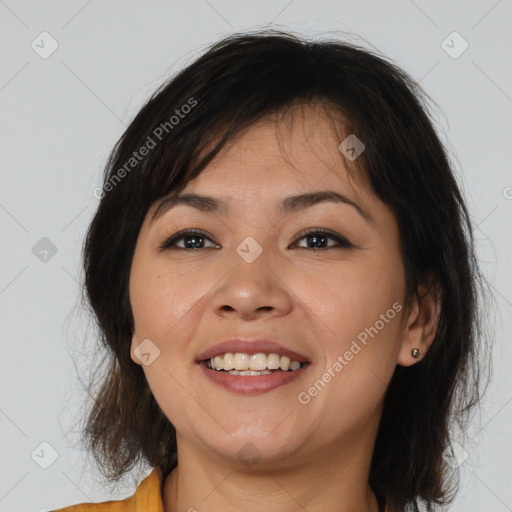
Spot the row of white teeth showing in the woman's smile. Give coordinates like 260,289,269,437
209,352,302,375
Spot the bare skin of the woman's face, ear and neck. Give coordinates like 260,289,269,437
130,106,440,512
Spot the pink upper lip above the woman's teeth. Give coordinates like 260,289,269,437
197,338,310,363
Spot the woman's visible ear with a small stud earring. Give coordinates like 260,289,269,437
397,274,441,366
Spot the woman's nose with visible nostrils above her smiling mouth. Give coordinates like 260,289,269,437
212,256,293,320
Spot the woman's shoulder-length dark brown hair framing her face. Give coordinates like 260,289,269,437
75,30,490,511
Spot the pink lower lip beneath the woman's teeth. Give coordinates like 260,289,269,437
199,364,310,395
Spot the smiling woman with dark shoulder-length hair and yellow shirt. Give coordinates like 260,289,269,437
52,30,492,512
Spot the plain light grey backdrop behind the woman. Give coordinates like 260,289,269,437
0,0,512,512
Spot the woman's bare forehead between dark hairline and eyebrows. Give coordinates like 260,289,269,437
185,106,364,195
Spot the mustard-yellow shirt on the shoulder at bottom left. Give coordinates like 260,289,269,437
52,467,164,512
